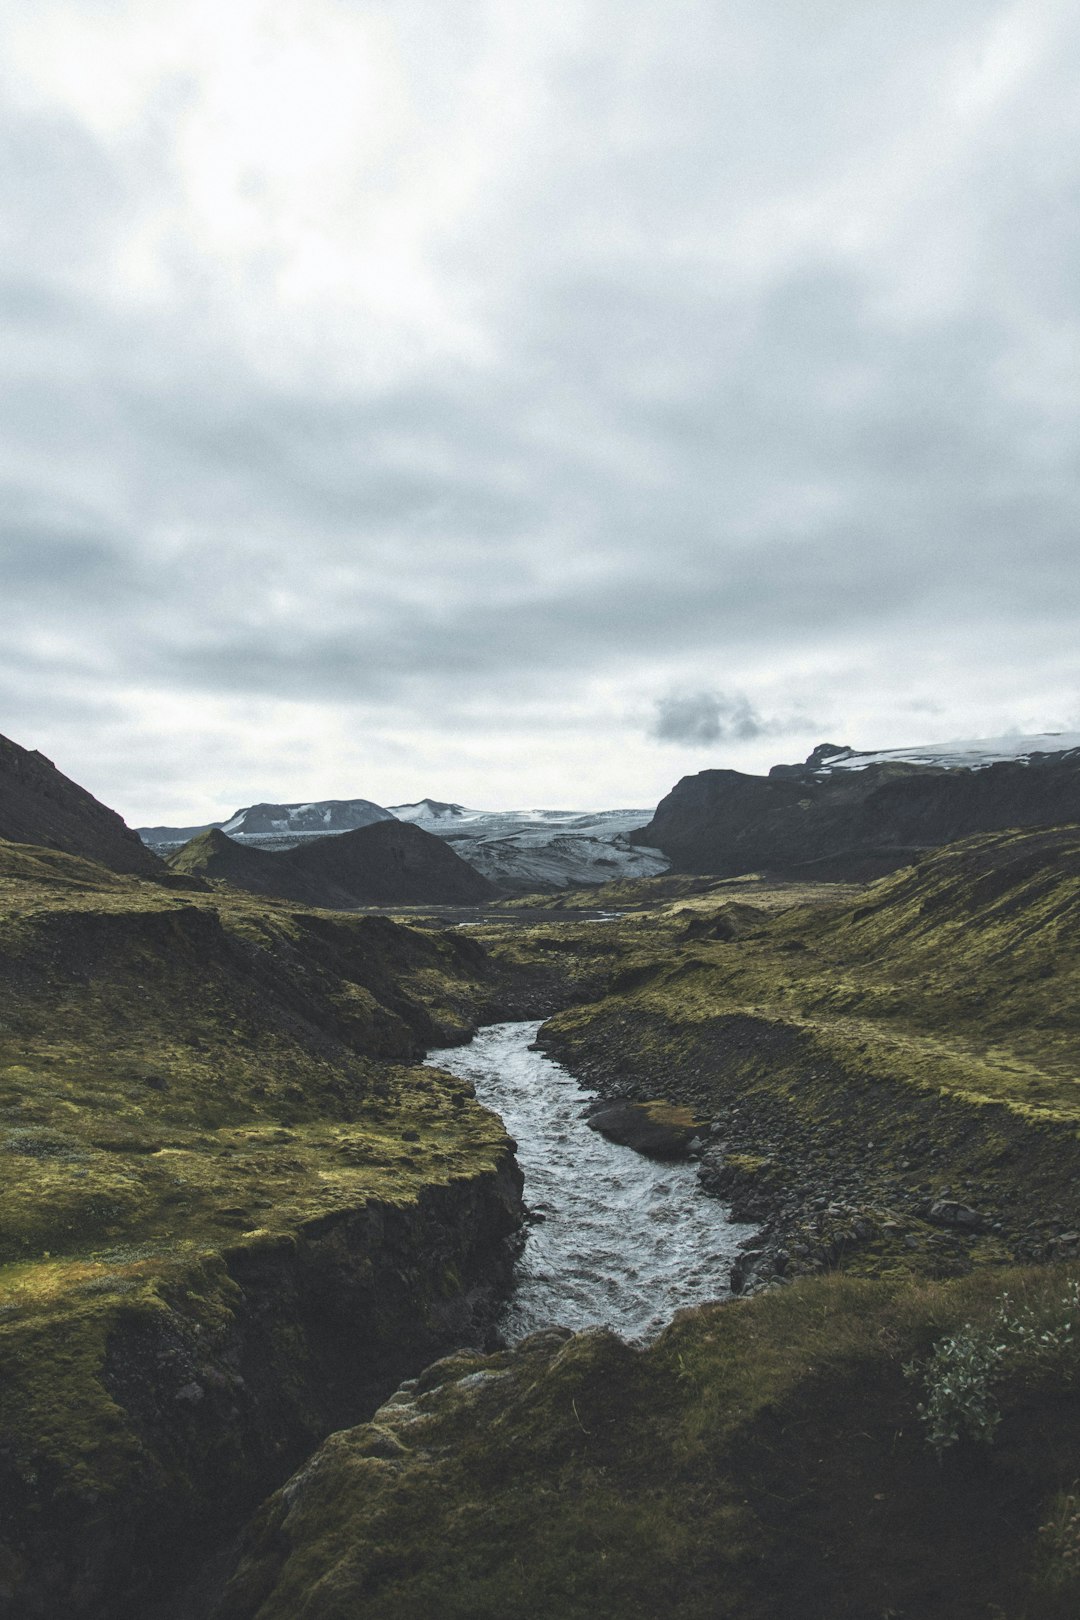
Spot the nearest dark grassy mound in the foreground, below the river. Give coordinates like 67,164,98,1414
217,1268,1080,1620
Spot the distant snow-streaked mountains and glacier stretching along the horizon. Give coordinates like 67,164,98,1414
127,732,1080,894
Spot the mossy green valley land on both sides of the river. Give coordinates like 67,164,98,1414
0,828,1080,1620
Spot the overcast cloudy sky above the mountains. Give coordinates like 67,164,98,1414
0,0,1080,825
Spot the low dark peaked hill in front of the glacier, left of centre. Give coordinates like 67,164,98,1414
168,820,497,909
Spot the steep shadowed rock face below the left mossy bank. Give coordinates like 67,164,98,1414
0,1149,521,1620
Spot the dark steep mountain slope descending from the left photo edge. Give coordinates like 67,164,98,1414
0,737,164,876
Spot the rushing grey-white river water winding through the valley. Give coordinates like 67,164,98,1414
427,1021,753,1343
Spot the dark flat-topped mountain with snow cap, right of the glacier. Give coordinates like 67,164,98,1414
635,735,1080,878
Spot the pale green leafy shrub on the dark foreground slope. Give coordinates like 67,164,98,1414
904,1281,1080,1456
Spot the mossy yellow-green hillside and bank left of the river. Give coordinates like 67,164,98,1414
0,846,517,1614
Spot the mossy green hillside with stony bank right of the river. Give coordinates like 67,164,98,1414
541,829,1080,1270
